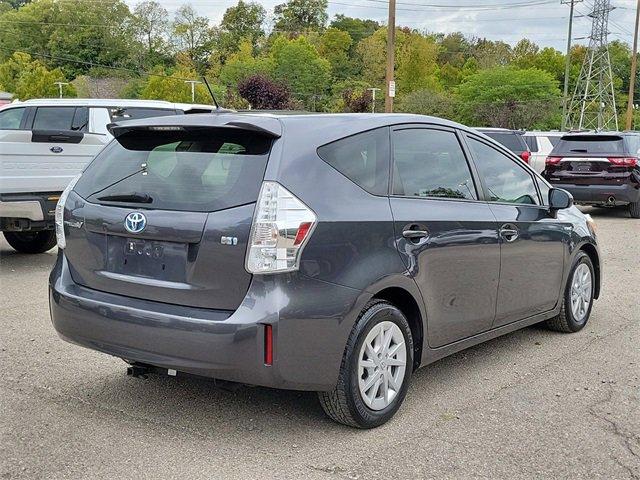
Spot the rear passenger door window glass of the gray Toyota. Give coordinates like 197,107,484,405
393,128,478,200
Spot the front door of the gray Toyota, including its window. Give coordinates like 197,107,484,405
466,134,571,327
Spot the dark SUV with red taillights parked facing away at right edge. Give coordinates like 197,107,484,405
543,132,640,218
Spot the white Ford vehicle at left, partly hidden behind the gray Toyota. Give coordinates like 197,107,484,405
0,99,214,253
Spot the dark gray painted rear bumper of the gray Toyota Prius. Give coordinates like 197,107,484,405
49,252,366,391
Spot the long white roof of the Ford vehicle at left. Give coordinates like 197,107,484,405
4,98,215,111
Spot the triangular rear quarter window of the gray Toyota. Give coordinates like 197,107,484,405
318,127,389,195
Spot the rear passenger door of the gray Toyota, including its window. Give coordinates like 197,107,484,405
390,125,500,347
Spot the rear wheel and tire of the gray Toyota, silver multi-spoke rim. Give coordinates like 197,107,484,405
318,300,413,429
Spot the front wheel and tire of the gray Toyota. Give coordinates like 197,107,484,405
546,252,595,333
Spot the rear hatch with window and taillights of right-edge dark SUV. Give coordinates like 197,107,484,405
545,134,637,185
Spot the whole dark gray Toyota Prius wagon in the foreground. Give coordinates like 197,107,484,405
49,113,601,428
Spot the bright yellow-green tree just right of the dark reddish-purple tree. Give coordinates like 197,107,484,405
270,36,331,108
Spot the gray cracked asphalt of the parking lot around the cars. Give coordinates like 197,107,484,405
0,209,640,479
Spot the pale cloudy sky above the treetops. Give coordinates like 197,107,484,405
127,0,636,52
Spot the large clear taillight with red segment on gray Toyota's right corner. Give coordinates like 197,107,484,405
246,181,316,273
